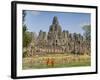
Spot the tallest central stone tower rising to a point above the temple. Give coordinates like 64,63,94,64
47,16,62,46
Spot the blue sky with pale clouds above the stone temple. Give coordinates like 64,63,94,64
25,11,91,34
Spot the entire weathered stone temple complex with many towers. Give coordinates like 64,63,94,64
28,16,91,55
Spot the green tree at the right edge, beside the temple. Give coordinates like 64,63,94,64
82,25,91,41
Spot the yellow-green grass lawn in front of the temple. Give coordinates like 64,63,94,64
22,54,91,69
